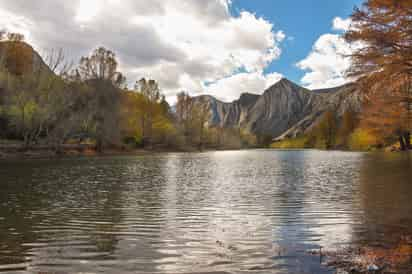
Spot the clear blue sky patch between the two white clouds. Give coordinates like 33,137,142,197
231,0,362,83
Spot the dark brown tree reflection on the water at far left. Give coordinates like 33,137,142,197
0,159,127,267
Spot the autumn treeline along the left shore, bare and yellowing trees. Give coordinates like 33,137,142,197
0,34,256,151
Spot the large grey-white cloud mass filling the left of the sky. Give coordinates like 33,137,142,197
0,0,286,101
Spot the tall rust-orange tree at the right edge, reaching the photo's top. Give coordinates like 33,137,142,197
345,0,412,149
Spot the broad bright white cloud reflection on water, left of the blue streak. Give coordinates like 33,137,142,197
159,152,275,272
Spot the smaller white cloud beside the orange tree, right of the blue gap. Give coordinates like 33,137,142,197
297,17,358,89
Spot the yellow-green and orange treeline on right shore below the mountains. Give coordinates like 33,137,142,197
271,104,412,151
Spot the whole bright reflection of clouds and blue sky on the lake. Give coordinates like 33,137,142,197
154,152,357,272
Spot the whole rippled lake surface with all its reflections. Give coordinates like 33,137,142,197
0,150,412,274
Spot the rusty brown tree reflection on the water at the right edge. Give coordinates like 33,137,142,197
356,154,412,244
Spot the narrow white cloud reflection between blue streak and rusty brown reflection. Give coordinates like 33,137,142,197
301,152,362,248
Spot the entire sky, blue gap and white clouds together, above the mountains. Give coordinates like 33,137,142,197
0,0,361,102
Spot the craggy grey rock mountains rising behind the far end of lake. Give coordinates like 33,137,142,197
195,79,361,138
